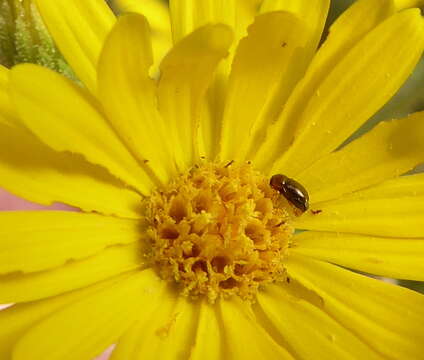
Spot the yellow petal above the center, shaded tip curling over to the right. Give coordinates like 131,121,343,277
158,24,232,170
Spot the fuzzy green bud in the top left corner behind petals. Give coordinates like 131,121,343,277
0,0,75,79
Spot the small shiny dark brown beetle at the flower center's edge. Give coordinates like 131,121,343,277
269,174,309,212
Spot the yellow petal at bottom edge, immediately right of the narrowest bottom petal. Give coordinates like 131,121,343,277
220,297,293,360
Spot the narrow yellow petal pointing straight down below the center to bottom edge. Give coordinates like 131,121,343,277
190,301,225,360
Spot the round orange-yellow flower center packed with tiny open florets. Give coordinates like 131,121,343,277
147,162,294,302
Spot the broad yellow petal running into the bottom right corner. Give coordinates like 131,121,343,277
286,256,424,360
